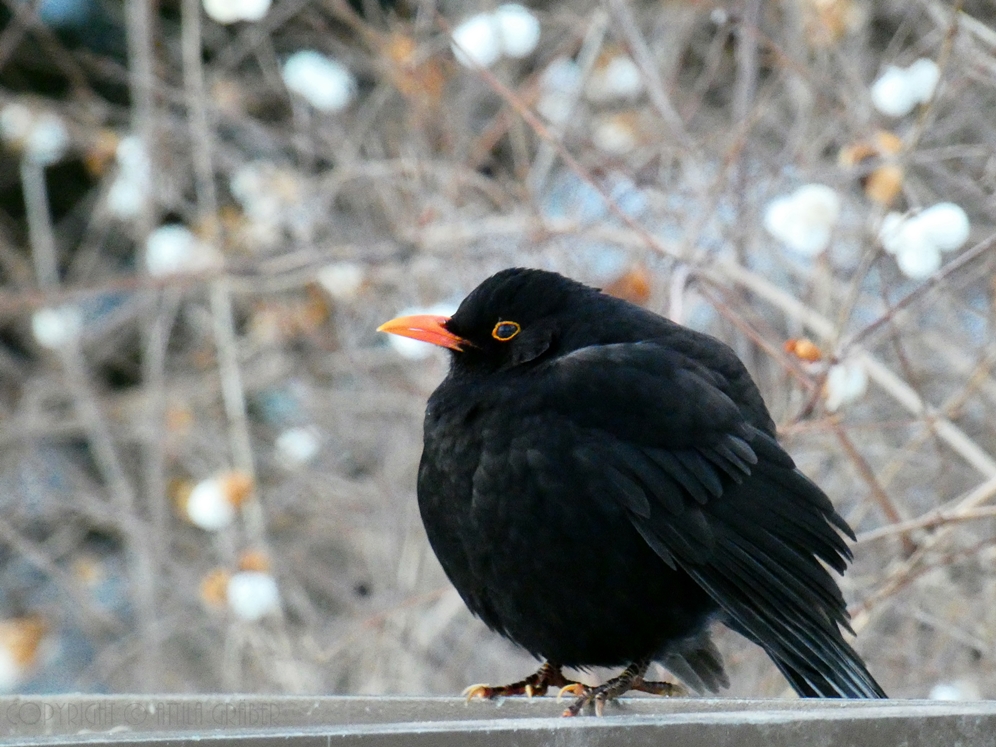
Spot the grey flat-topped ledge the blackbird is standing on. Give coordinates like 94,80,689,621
0,695,996,747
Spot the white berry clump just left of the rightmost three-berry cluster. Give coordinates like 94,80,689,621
764,184,840,257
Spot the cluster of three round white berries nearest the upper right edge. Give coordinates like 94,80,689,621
879,202,971,280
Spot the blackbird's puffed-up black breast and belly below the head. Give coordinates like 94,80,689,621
419,380,712,665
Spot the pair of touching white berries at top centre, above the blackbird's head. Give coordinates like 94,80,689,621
451,3,540,67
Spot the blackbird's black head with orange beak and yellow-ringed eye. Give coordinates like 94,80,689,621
378,268,606,370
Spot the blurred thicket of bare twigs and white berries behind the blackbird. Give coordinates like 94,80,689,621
0,0,996,698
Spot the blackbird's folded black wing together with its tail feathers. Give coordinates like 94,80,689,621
543,342,883,697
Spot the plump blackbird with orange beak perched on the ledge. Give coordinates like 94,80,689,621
379,268,886,715
